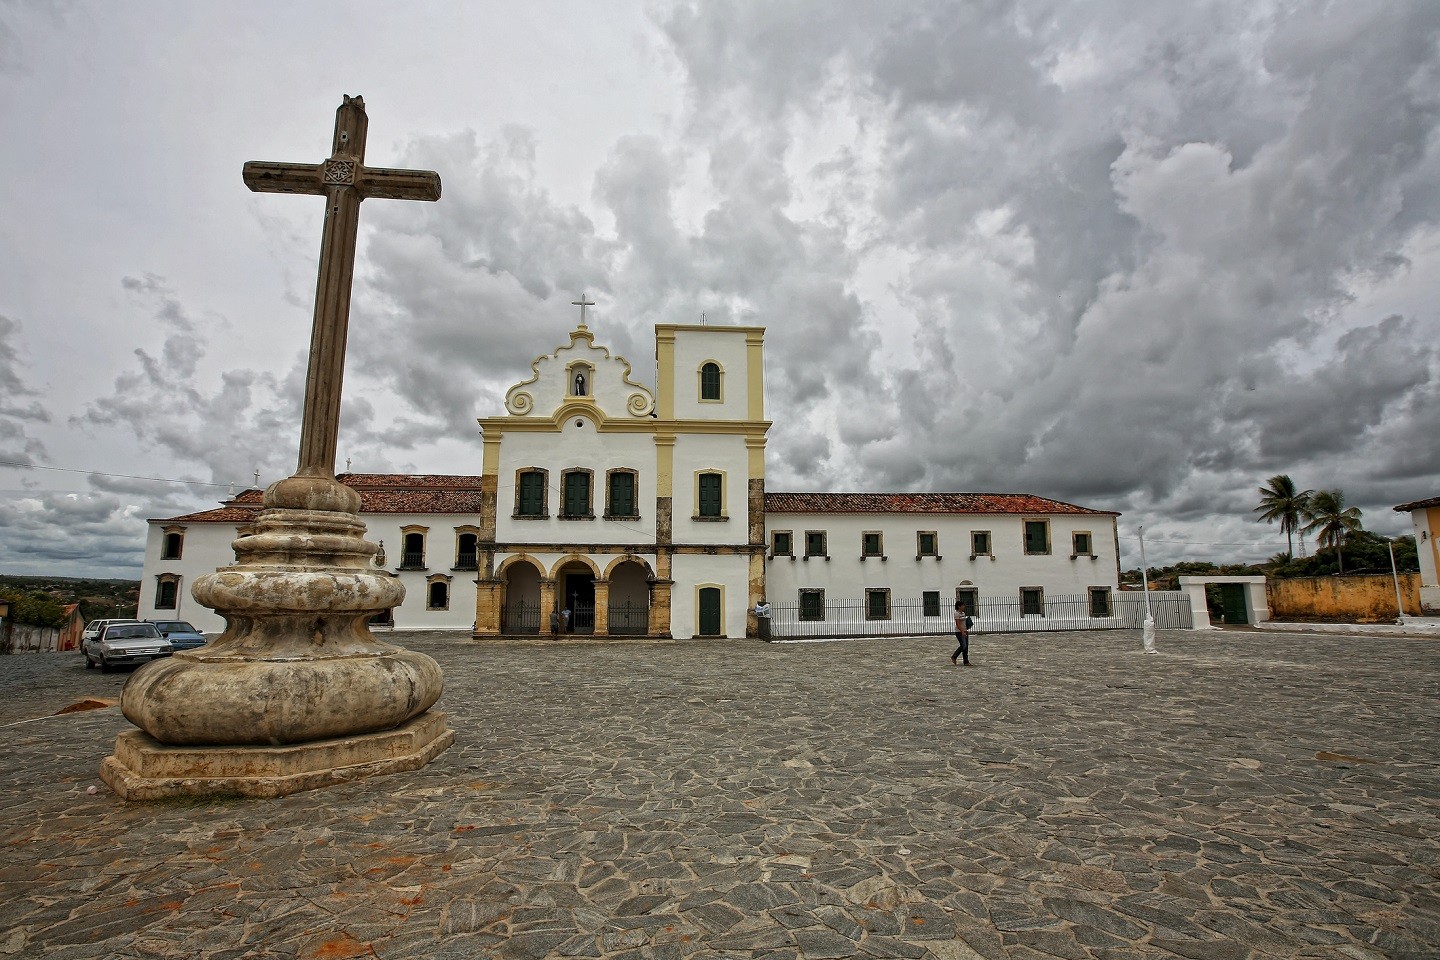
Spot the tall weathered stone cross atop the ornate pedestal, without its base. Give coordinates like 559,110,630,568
245,96,441,478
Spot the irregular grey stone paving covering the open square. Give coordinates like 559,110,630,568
0,632,1440,960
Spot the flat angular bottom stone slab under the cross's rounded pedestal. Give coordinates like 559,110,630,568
99,712,455,800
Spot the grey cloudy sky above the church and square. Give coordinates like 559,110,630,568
0,0,1440,576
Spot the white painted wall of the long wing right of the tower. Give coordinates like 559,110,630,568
765,514,1119,603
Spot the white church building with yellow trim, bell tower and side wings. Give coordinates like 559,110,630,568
140,319,1119,639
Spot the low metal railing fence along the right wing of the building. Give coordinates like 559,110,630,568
770,590,1192,639
